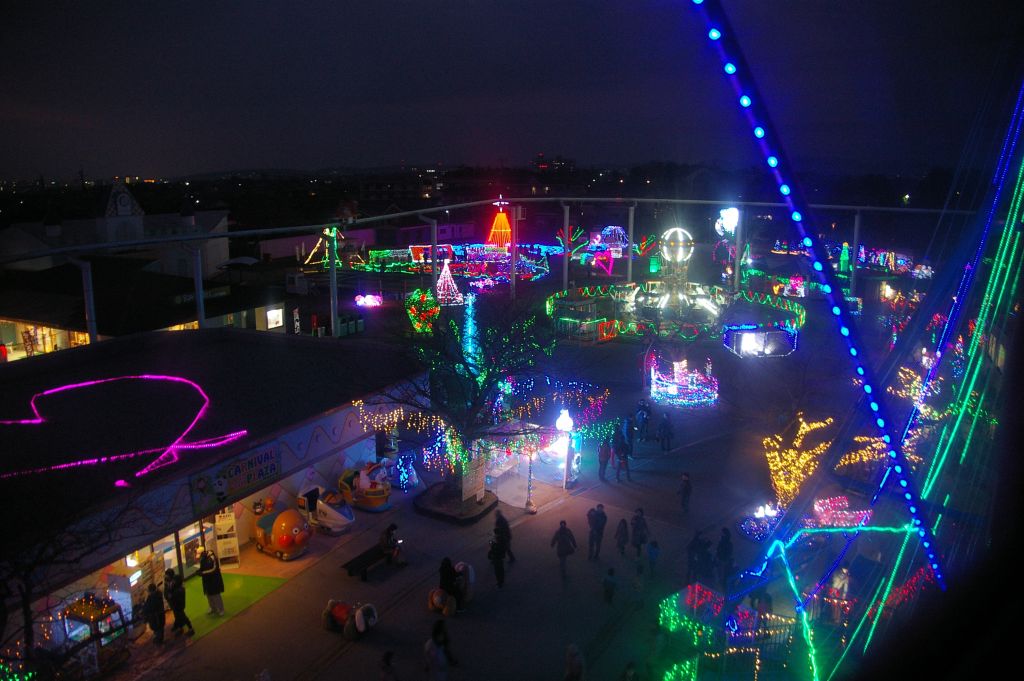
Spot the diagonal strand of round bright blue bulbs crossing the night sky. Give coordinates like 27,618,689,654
694,2,945,590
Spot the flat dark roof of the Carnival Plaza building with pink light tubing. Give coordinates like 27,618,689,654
0,329,417,527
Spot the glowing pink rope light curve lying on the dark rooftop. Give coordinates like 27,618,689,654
0,374,249,486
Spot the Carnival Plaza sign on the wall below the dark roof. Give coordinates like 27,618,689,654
188,442,281,515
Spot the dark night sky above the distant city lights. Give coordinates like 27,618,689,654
0,0,1019,179
